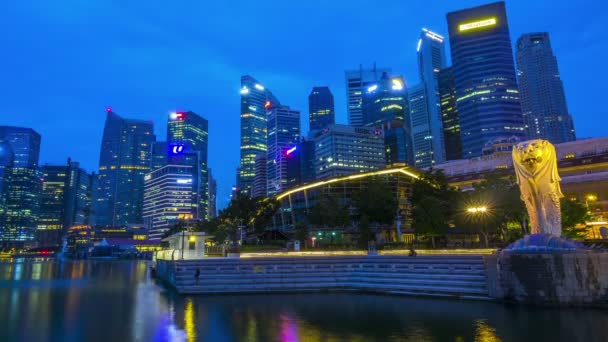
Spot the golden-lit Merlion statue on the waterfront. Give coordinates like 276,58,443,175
513,139,564,237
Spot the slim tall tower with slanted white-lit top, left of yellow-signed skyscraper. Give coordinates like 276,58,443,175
409,28,445,168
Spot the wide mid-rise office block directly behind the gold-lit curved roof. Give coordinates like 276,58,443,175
314,125,386,180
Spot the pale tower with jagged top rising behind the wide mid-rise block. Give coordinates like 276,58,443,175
344,64,391,126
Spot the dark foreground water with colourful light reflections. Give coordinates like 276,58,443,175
0,261,608,342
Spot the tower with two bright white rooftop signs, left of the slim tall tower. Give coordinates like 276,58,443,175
363,73,414,165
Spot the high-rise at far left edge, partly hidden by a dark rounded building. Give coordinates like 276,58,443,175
0,126,41,246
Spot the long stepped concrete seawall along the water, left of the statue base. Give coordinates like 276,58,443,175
156,255,490,299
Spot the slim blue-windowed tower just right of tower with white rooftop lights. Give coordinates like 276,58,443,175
266,106,300,196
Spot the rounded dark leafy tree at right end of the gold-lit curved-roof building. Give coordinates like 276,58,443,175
412,169,458,248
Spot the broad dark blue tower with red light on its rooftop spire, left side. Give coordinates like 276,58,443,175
94,108,156,227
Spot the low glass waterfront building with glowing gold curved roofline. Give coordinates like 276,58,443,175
274,166,419,242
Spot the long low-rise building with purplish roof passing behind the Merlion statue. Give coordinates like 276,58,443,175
435,138,608,232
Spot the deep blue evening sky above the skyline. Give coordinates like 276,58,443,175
0,0,608,208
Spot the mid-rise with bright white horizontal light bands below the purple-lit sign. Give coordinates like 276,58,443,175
143,165,200,240
